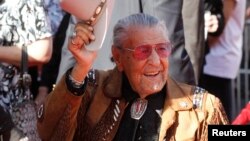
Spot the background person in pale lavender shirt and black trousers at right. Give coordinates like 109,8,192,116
200,0,246,121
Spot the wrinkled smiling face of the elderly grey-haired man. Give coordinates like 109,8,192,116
113,26,169,98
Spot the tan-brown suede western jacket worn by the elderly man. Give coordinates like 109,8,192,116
38,68,229,141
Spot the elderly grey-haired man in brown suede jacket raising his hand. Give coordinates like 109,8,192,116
38,14,228,141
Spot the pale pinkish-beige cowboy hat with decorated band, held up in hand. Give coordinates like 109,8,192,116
60,0,114,51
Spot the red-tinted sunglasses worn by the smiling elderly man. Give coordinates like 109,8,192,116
120,42,172,60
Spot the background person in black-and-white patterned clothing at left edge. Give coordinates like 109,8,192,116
0,0,52,141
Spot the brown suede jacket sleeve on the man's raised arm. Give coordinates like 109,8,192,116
37,76,83,141
